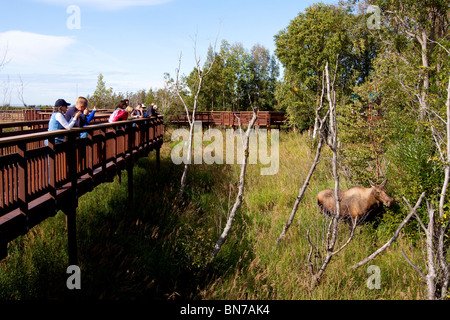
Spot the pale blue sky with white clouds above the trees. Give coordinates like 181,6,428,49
0,0,337,105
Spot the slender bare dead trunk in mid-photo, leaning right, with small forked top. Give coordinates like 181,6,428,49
210,106,258,261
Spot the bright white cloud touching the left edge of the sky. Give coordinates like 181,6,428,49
0,31,76,65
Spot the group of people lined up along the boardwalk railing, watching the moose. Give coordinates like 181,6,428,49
46,97,158,144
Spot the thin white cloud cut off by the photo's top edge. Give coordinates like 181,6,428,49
35,0,173,10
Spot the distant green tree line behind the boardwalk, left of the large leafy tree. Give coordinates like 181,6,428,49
89,40,280,113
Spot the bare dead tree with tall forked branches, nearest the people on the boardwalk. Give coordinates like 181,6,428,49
175,40,217,200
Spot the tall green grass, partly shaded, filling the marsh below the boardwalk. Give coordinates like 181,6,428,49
0,132,424,300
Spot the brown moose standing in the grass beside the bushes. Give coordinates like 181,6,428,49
317,179,394,223
